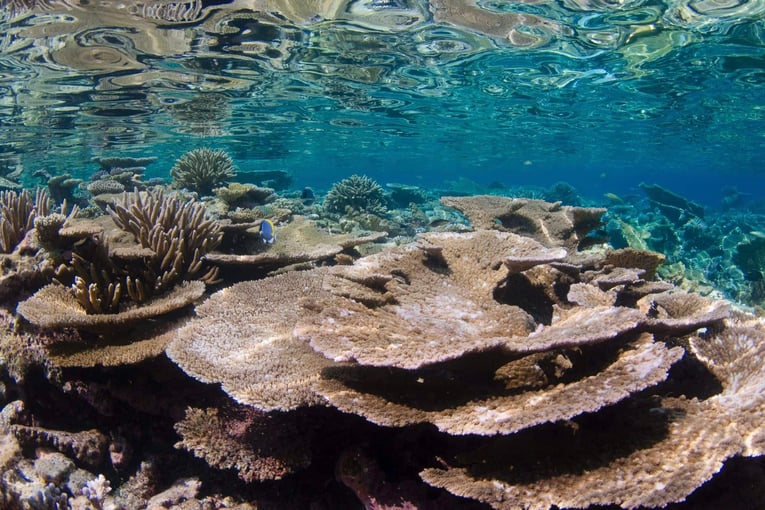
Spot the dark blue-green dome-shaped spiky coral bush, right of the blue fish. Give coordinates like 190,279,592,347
324,175,387,215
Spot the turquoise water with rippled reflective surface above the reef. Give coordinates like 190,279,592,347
0,0,765,207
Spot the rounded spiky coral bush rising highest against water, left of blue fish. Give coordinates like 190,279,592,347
170,148,236,195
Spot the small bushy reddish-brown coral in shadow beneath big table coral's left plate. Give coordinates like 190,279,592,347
175,408,310,482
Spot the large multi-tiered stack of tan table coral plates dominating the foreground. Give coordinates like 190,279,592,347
168,218,765,509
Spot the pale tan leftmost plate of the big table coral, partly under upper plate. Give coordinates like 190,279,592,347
167,270,331,410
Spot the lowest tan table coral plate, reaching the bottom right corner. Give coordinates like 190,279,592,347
421,324,765,510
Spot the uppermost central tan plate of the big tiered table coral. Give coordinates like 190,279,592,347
295,230,546,369
